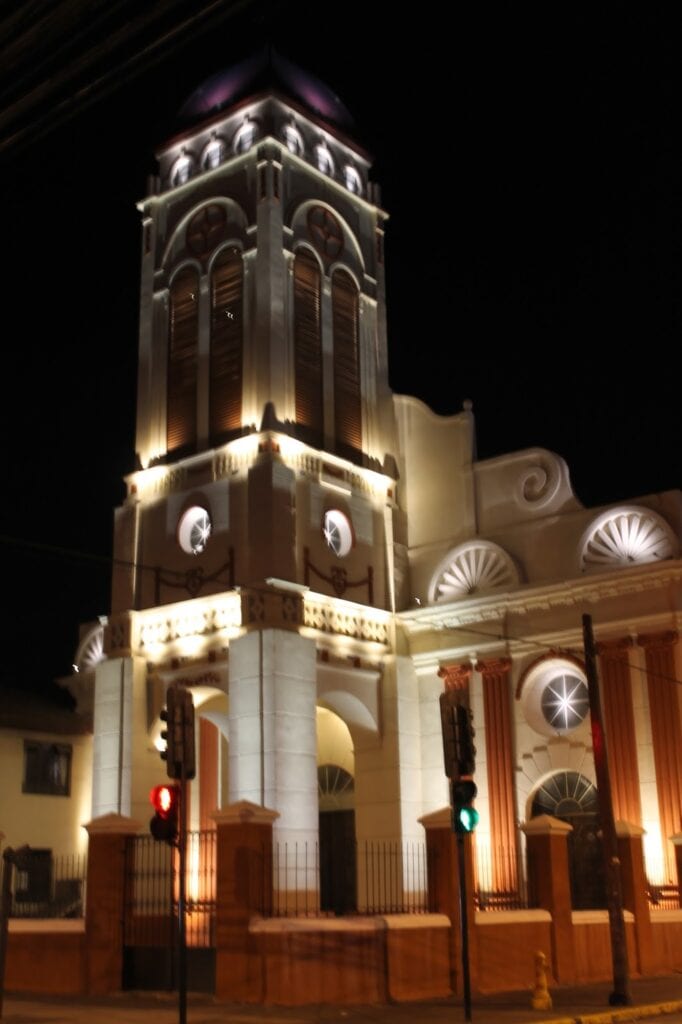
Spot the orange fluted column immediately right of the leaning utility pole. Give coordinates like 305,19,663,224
597,637,642,825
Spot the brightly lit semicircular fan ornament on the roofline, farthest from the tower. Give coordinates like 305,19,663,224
581,506,678,571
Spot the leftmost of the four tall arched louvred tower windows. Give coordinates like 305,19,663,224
166,267,199,452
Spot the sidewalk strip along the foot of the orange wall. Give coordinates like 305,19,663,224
2,974,682,1024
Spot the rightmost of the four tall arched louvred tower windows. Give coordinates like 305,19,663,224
332,270,363,456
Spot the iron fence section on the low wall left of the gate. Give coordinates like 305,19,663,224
10,849,87,919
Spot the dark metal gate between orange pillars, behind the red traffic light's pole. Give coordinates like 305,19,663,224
122,829,216,992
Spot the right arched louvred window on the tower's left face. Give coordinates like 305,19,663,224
209,248,244,437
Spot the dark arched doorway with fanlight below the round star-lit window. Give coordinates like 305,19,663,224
530,771,607,910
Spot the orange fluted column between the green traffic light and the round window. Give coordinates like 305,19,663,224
476,657,517,892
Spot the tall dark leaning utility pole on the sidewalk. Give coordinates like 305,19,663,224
583,615,632,1007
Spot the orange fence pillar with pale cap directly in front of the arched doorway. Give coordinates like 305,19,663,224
521,814,576,985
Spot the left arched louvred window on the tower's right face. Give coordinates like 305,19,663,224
294,249,325,444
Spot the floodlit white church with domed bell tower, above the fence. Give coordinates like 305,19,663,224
71,54,682,905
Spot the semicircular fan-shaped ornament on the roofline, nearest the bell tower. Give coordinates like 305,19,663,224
429,541,519,601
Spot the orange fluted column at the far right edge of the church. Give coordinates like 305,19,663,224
638,631,682,883
